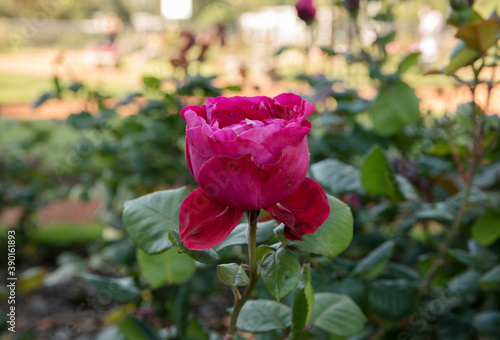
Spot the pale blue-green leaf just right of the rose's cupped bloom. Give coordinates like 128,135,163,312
311,159,364,195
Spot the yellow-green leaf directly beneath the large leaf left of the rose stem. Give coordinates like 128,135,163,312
137,248,196,288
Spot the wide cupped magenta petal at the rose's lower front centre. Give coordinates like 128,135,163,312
195,138,309,210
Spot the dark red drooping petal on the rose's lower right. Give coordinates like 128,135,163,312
266,178,330,241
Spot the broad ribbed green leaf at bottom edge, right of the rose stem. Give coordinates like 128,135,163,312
311,293,367,337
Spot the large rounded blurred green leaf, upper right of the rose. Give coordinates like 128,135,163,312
371,80,420,136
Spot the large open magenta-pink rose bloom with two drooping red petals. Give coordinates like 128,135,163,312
179,93,330,250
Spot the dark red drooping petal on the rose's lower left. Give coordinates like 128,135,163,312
179,189,244,250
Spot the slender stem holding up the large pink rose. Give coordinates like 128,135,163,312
224,210,260,340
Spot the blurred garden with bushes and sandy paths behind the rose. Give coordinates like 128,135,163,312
0,0,500,340
